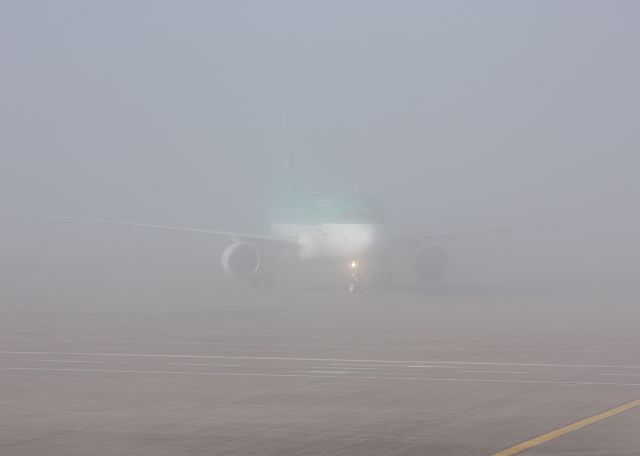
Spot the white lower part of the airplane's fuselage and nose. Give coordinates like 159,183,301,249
271,223,382,260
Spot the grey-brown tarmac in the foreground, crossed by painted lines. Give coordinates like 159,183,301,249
0,286,640,456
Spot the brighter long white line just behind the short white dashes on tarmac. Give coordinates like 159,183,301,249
0,351,640,369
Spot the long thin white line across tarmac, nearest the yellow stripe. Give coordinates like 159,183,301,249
0,367,640,386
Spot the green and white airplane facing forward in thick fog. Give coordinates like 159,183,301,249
48,153,544,293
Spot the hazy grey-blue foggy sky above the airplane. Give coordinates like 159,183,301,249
0,0,640,292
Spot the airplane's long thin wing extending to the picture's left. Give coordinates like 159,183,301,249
46,215,298,247
